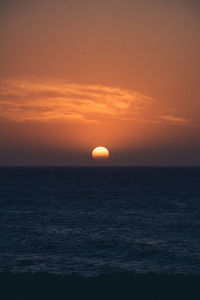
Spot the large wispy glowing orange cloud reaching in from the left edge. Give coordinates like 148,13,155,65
0,78,153,123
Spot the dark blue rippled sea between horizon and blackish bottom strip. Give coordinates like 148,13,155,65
0,167,200,276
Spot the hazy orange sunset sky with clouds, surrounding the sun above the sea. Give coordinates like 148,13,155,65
0,0,200,166
